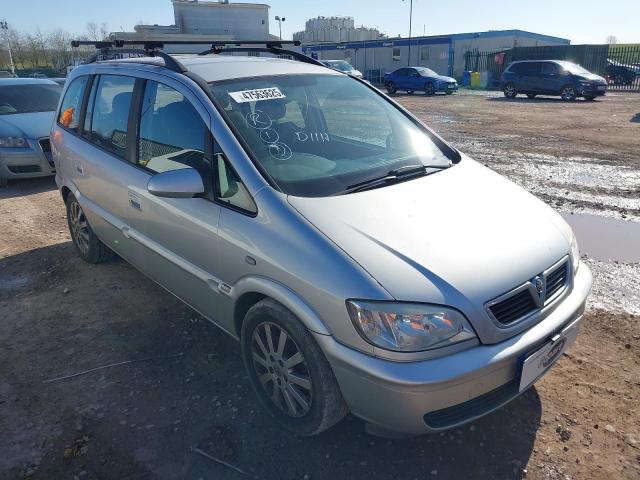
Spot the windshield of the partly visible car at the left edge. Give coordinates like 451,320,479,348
0,84,62,115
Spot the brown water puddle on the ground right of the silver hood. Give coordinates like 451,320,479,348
561,213,640,263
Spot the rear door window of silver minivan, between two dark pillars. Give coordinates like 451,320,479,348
85,75,135,158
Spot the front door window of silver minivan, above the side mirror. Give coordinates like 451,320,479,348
138,80,211,175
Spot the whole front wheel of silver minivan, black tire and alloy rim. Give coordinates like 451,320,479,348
241,299,348,436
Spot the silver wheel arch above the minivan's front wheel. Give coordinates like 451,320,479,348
231,277,331,338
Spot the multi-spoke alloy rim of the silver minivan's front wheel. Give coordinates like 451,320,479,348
251,322,313,417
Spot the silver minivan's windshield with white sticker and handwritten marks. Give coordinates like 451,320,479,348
210,74,450,197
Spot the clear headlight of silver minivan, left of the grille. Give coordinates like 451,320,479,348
347,300,476,352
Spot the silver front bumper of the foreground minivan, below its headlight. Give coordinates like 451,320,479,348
315,264,592,435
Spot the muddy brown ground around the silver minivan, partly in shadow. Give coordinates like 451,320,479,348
0,94,640,480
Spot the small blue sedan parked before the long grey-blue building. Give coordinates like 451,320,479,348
384,67,458,95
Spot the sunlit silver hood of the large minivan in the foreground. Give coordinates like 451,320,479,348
289,157,571,343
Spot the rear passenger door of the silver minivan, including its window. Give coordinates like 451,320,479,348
54,74,147,266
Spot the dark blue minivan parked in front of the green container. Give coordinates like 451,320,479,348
500,60,607,101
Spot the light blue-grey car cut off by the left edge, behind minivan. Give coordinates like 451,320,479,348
0,78,61,186
